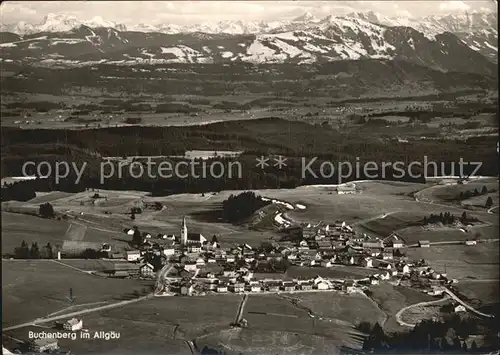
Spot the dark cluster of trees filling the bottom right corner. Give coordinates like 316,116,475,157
357,314,499,353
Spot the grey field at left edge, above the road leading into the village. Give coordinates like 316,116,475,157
2,260,151,327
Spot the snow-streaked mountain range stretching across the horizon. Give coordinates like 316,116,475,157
0,12,498,75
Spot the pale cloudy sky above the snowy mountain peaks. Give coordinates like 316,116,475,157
0,0,497,25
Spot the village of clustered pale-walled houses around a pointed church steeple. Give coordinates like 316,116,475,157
84,211,476,304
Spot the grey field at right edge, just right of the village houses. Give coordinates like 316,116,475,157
407,242,499,280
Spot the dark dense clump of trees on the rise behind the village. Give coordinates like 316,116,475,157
222,191,271,223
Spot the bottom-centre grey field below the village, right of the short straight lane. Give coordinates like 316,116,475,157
196,295,366,354
